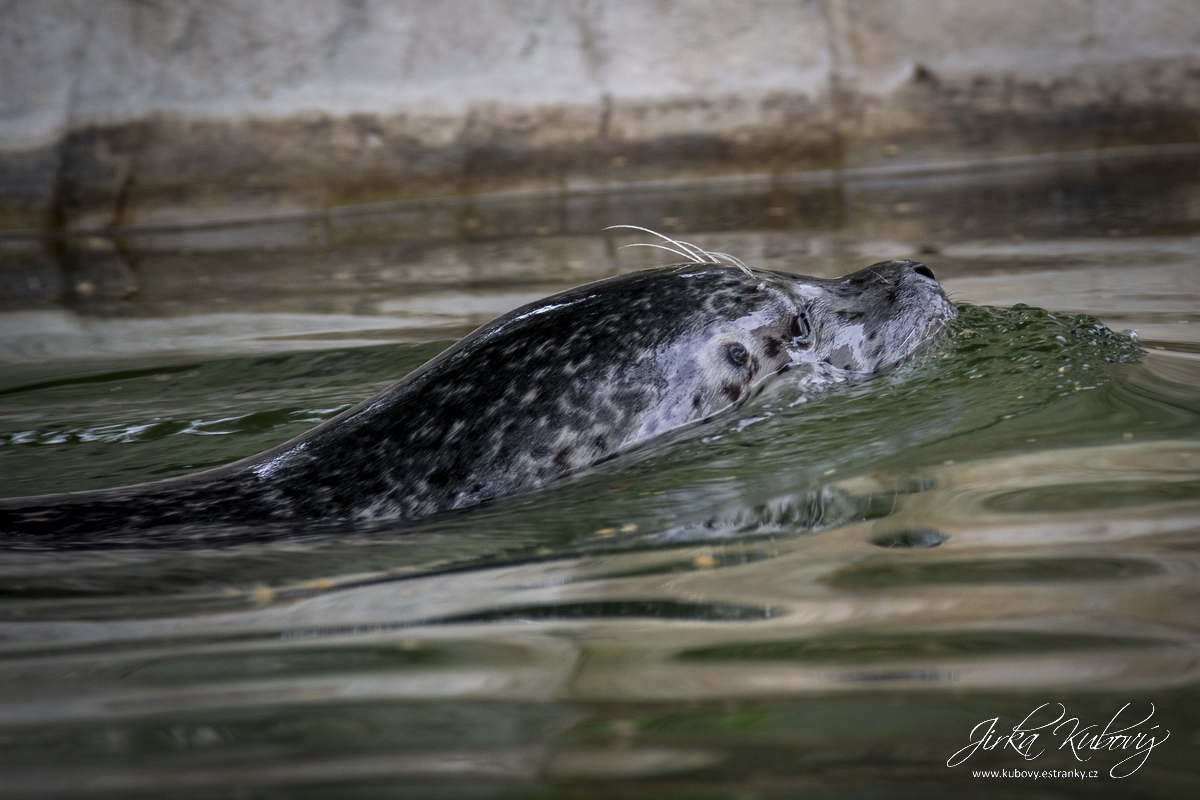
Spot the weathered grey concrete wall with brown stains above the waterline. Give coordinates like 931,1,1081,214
0,0,1200,230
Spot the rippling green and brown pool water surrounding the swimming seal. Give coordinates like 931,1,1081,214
0,148,1200,798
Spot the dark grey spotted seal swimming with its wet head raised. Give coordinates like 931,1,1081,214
0,260,955,541
